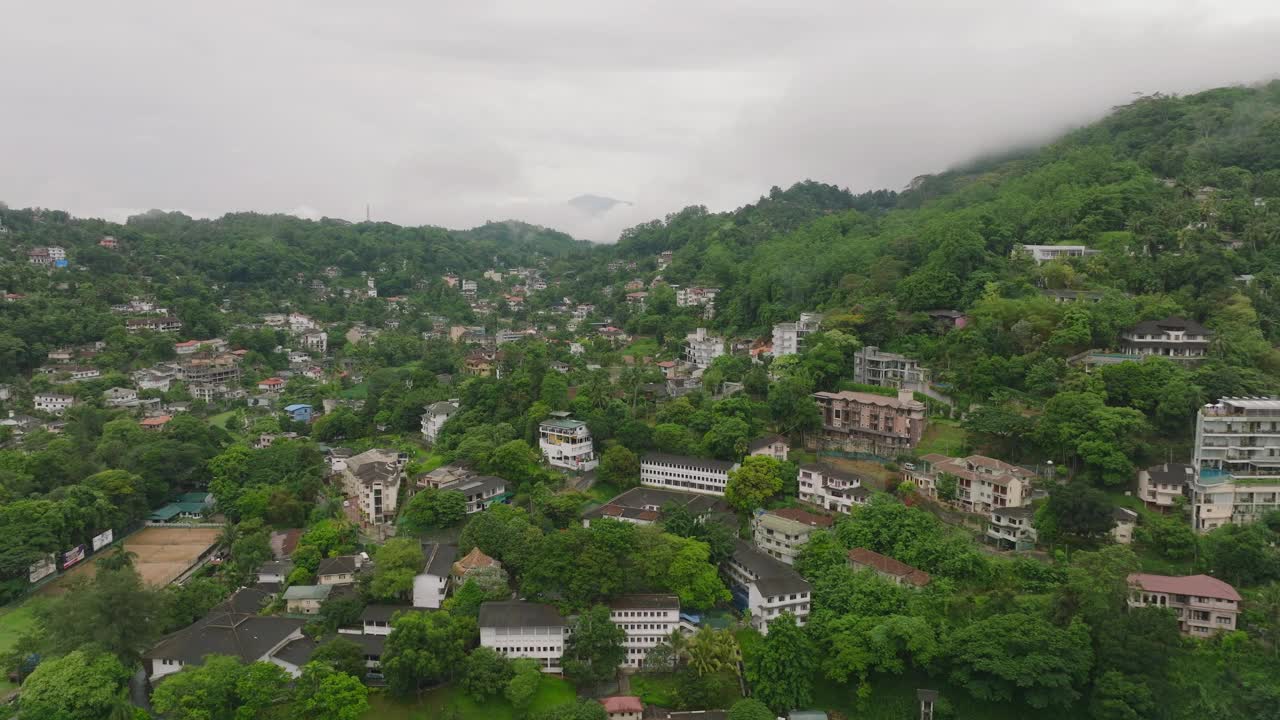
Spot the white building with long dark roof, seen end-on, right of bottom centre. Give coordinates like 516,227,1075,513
723,539,810,635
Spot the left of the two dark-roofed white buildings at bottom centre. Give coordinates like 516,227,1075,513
480,600,570,673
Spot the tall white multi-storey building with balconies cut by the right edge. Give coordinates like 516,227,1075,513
1192,397,1280,532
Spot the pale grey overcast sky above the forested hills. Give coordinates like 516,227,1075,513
0,0,1280,242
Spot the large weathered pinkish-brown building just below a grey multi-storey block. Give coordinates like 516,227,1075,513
813,389,925,457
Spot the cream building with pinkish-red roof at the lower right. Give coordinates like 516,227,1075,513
1129,573,1240,638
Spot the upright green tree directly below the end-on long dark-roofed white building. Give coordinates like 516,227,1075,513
746,612,818,712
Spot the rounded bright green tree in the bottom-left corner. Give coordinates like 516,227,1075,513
19,650,129,720
